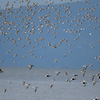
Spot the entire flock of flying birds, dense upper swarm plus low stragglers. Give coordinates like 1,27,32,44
0,0,100,100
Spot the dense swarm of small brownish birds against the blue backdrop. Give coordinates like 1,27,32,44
0,0,100,66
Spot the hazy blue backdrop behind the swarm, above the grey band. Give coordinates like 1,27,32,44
0,0,100,69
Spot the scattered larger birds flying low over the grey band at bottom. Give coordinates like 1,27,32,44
0,65,100,100
